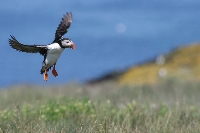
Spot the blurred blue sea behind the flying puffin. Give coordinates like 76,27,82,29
0,0,200,87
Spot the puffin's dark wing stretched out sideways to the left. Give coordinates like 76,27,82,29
8,35,47,55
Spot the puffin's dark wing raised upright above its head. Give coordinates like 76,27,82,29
54,12,72,42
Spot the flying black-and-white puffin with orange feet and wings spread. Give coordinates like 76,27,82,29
8,12,76,81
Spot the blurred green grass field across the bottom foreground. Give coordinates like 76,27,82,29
0,79,200,133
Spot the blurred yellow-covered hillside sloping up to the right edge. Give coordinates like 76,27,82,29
118,44,200,84
